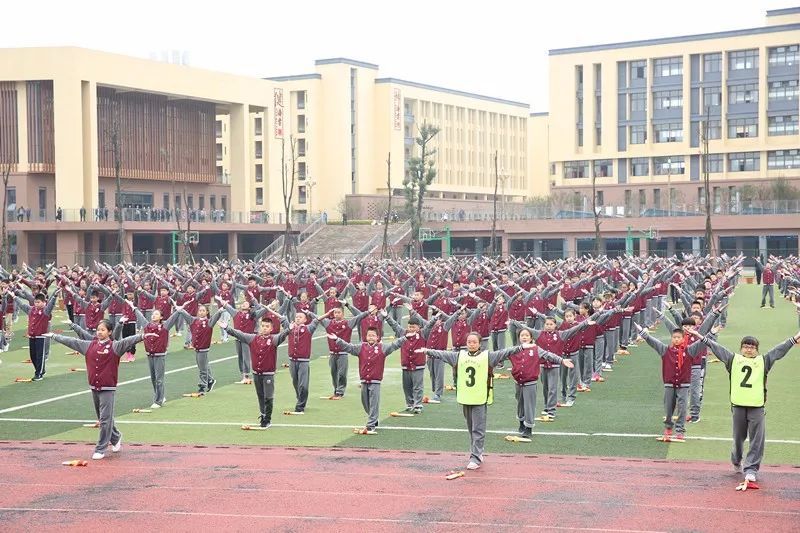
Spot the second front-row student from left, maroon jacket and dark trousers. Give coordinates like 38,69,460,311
220,318,289,429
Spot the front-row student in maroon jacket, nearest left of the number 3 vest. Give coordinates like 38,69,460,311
328,324,406,435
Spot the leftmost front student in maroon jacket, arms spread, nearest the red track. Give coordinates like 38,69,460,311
46,319,155,460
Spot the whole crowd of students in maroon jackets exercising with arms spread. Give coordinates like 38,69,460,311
0,255,800,481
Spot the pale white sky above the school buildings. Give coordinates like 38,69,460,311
0,0,797,111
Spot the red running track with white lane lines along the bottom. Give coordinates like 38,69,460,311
0,441,800,533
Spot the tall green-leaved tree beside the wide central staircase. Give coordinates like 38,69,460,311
403,123,440,257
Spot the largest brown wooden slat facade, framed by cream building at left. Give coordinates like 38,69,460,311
97,87,216,183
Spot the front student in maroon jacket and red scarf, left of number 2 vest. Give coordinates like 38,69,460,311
636,324,703,442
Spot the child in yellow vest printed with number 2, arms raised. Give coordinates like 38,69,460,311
686,328,800,490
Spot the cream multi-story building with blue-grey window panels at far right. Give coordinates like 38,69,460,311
542,8,800,214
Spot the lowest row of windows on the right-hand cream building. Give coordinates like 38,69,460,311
564,149,800,179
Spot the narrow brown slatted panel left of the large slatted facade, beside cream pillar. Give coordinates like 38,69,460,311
27,80,56,172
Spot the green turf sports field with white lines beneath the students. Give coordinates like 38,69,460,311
0,285,800,465
